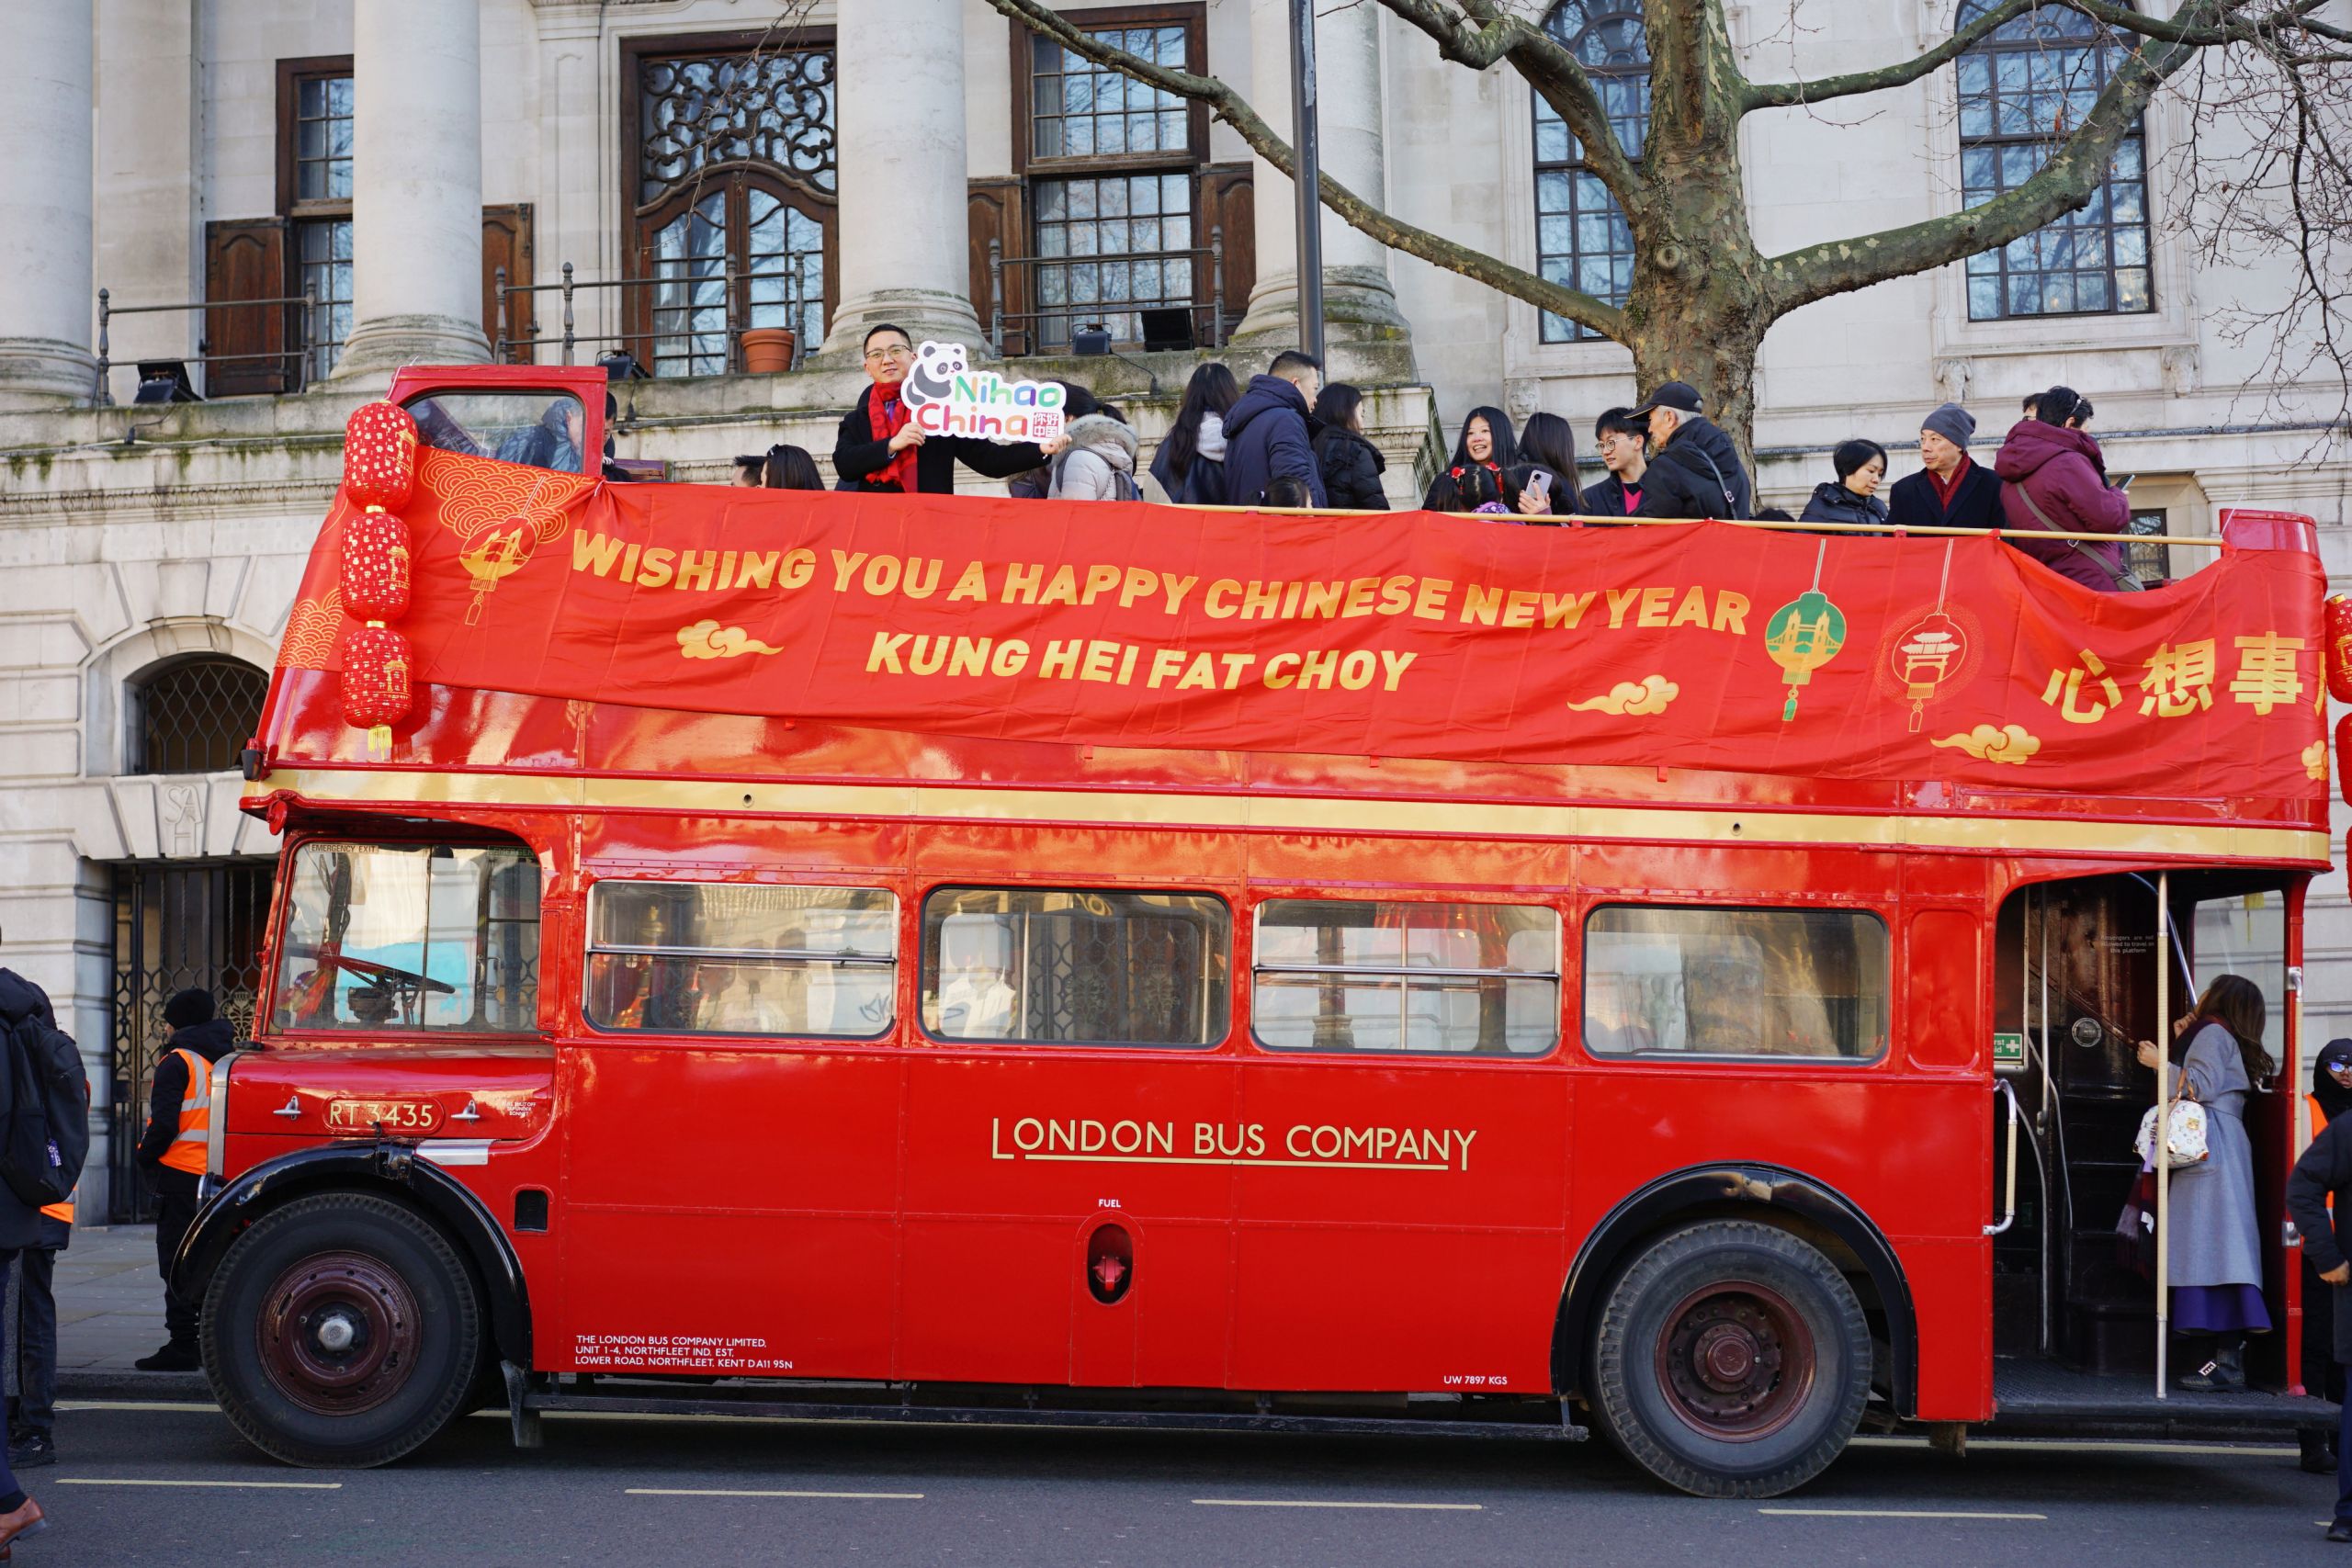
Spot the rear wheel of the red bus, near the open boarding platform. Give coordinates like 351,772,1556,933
1592,1220,1870,1497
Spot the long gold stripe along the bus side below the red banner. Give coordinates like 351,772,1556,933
247,769,2328,865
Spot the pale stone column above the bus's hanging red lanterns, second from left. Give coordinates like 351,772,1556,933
334,0,489,376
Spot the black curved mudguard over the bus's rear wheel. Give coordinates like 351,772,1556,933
1553,1161,1919,1416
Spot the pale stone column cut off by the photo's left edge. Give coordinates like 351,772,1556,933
0,0,99,409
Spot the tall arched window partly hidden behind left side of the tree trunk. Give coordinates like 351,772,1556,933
1536,0,1649,344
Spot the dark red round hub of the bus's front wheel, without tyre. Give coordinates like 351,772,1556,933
254,1253,421,1416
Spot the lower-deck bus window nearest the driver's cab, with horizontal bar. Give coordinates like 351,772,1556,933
588,882,899,1039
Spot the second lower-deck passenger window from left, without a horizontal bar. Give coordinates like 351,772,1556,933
922,888,1232,1046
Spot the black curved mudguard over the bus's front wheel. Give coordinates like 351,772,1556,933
172,1140,532,1366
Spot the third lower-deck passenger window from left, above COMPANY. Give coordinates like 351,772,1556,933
1249,898,1559,1055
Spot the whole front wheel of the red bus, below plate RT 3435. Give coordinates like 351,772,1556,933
200,1192,482,1467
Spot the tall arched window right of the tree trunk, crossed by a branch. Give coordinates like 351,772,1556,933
1954,0,2157,322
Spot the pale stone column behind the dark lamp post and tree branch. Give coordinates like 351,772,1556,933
1232,0,1411,357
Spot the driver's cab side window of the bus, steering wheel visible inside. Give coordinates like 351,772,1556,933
277,844,538,1032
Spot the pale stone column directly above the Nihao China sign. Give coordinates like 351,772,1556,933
823,0,988,365
